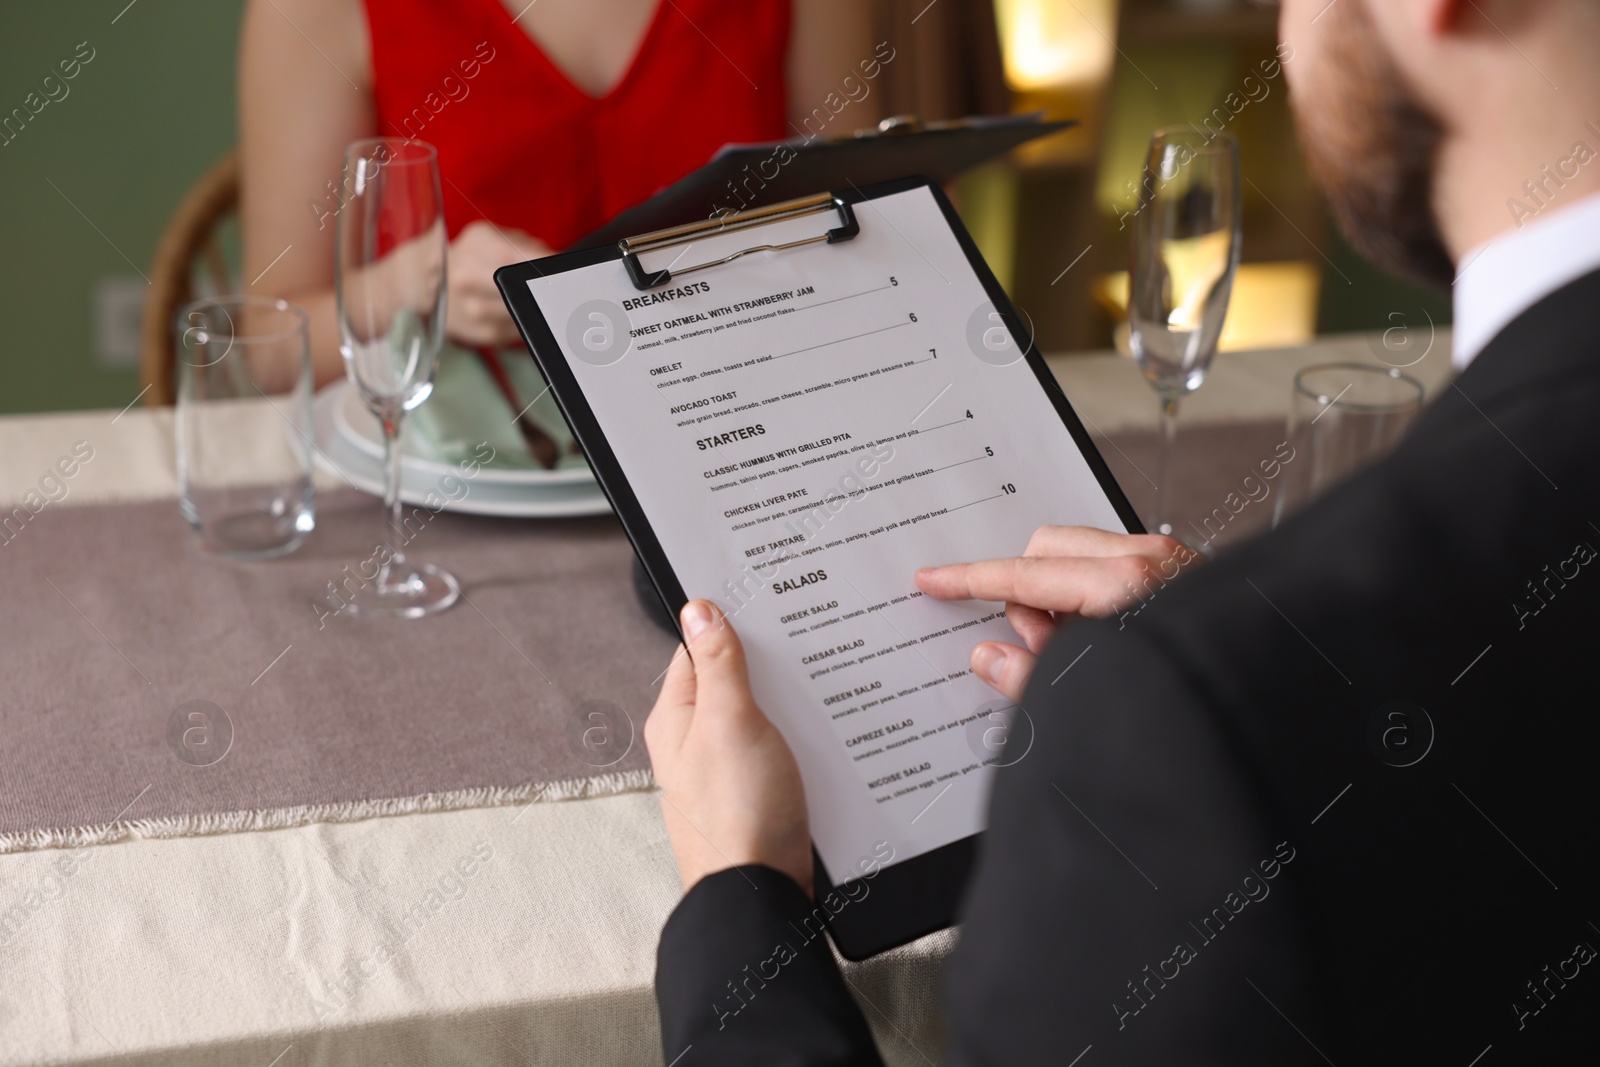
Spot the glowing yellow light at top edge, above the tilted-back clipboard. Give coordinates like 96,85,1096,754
995,0,1117,93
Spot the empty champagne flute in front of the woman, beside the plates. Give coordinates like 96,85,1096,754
334,138,461,619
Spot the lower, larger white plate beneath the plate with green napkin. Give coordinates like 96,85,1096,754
310,382,611,518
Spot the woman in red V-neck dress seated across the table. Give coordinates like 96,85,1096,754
238,0,878,386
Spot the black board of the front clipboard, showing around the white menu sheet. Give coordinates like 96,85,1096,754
494,176,1144,960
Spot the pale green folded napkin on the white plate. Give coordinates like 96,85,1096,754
403,341,589,470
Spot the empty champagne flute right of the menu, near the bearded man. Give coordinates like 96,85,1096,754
1128,126,1240,536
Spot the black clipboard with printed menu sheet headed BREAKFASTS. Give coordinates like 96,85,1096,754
494,178,1142,960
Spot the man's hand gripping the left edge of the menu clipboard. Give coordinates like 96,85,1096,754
645,600,811,896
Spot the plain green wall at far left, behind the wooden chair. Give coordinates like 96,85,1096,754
0,0,242,411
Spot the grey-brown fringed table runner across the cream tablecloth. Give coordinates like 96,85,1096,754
0,422,1283,851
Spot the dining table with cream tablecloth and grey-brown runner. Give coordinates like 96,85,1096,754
0,330,1451,1067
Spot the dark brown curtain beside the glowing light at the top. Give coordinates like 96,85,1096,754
874,0,1011,120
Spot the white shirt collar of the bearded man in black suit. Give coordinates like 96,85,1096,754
1451,194,1600,371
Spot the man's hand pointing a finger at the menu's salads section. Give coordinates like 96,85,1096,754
917,526,1200,701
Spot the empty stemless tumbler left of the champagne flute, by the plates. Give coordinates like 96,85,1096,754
174,296,315,560
